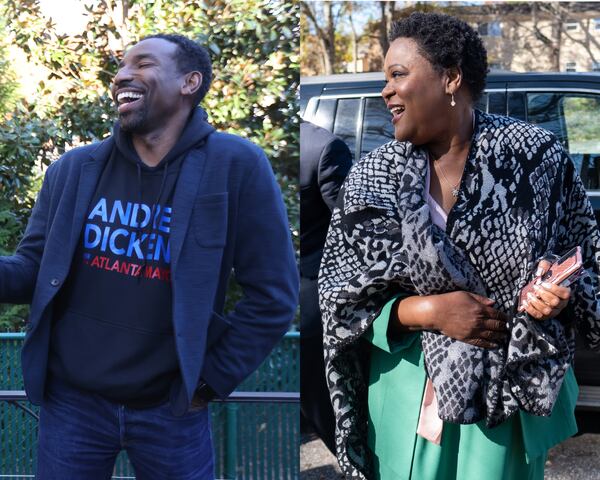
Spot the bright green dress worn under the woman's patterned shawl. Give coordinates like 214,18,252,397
366,299,578,480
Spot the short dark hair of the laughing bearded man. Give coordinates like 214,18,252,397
140,33,212,106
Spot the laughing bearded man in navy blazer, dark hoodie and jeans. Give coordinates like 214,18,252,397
0,31,298,480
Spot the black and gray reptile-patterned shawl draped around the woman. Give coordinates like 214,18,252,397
319,112,600,479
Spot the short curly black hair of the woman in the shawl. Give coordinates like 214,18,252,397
389,12,488,102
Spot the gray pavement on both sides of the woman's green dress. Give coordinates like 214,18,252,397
300,433,600,480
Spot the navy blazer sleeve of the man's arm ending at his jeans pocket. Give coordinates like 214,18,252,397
201,152,298,397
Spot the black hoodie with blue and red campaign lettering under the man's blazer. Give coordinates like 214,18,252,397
49,109,214,408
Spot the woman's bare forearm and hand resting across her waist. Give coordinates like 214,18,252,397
393,291,508,348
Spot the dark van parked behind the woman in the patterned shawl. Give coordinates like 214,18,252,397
300,72,600,433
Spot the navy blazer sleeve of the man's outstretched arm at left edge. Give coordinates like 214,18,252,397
0,167,49,303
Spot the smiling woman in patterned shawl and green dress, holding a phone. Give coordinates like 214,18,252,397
319,13,600,480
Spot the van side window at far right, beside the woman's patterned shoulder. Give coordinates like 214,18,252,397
527,93,600,190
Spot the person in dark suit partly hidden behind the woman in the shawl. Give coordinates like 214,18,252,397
300,122,352,453
